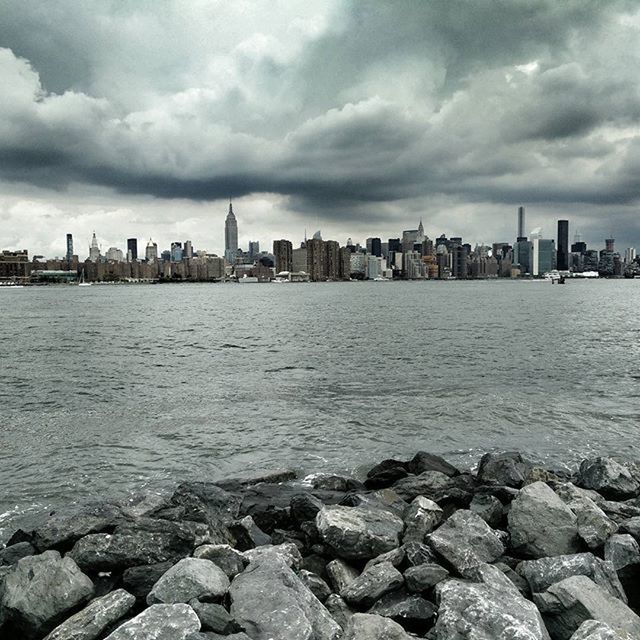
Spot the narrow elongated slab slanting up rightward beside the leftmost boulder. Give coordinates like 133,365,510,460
45,589,136,640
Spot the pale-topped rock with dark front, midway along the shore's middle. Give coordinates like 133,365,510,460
316,506,404,560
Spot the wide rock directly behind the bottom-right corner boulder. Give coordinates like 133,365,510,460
516,553,627,602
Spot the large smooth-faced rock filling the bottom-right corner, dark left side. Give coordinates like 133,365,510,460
533,576,640,640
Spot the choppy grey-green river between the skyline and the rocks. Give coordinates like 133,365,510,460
0,280,640,538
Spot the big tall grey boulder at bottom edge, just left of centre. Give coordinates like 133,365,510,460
229,556,341,640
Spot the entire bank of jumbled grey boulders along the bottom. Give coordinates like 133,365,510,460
0,452,640,640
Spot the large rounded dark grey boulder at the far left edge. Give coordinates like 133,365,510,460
0,551,93,638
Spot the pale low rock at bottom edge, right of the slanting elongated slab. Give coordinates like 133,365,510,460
105,604,200,640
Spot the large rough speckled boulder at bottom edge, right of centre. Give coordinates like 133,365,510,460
432,564,549,640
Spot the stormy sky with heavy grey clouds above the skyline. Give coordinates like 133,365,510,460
0,0,640,258
